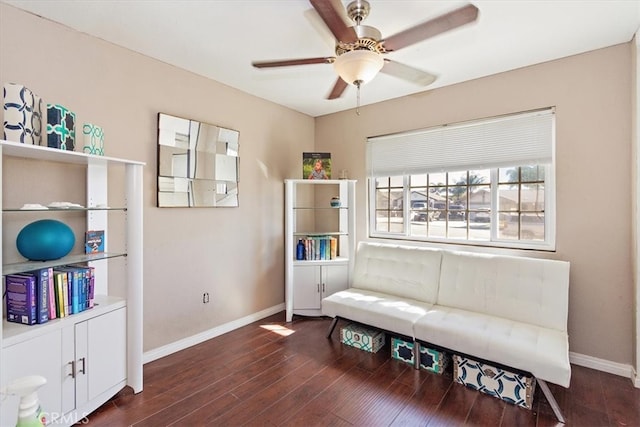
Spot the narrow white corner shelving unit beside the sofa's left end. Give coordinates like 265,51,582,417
285,179,356,322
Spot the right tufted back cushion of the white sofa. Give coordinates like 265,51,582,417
438,251,569,332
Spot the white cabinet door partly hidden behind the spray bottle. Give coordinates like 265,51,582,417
0,330,62,426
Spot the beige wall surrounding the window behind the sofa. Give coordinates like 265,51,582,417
315,44,634,364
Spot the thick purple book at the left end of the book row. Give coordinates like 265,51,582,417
5,274,38,325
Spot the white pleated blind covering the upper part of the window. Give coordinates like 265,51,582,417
367,108,555,177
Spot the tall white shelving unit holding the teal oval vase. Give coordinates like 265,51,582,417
0,140,144,426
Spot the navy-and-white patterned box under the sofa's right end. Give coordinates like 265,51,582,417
453,354,536,409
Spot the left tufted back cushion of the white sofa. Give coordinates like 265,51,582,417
351,242,442,303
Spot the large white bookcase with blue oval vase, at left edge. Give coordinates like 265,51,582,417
0,140,144,425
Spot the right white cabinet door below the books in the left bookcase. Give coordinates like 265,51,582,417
86,308,127,400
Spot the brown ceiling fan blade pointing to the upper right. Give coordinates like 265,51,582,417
383,4,478,51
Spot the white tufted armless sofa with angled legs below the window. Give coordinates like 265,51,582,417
322,242,571,422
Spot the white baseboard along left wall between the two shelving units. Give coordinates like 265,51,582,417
142,303,284,364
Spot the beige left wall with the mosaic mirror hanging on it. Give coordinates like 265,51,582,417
0,4,314,350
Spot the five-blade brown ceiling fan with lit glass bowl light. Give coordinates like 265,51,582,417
252,0,478,99
